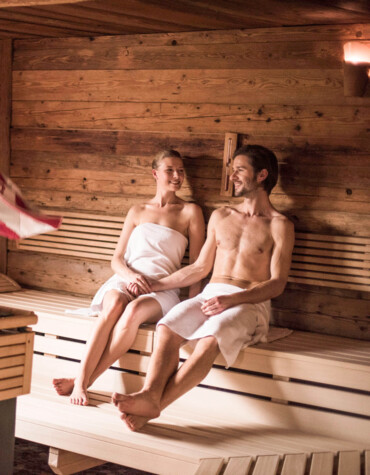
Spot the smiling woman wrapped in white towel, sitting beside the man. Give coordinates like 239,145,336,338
53,150,204,405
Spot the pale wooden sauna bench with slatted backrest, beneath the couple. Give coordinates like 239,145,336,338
0,213,370,475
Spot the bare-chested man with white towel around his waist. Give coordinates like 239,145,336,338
112,145,294,430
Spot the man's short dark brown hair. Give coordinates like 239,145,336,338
233,145,279,195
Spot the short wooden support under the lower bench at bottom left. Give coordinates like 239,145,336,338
48,447,105,475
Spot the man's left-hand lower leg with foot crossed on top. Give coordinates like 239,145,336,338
112,325,184,418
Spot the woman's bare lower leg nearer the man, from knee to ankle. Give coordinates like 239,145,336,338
89,297,162,386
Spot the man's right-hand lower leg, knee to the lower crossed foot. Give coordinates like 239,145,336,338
118,334,220,430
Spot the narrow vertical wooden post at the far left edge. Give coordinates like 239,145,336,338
0,40,12,274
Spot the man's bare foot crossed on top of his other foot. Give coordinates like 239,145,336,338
112,391,160,419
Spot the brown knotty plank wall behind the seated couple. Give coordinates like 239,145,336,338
8,25,370,338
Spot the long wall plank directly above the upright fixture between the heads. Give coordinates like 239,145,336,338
12,100,368,138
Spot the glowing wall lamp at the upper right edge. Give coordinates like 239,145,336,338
343,41,370,97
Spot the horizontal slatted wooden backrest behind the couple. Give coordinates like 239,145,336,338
10,212,370,290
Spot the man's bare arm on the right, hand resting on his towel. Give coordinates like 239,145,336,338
202,219,294,316
